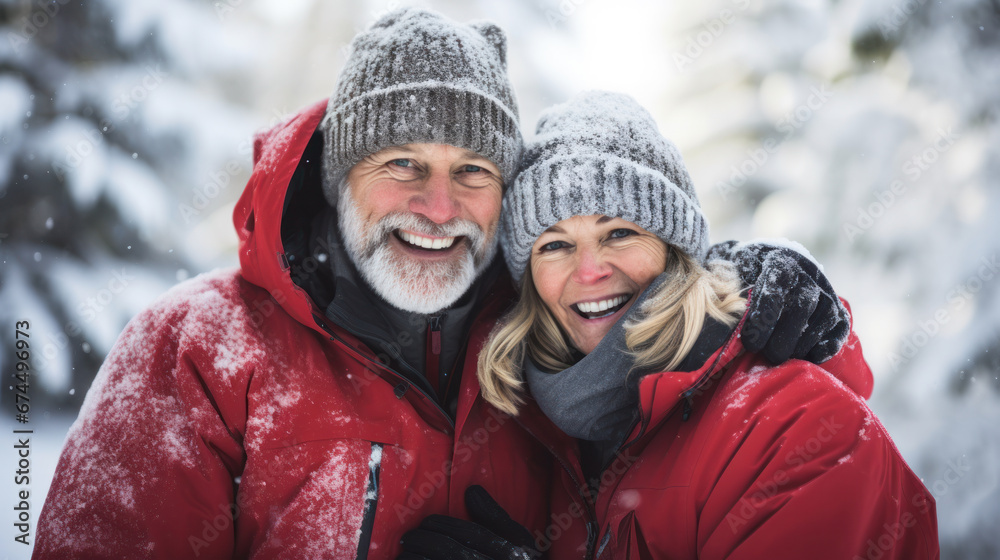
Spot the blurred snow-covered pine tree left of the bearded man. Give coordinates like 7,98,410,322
0,0,254,414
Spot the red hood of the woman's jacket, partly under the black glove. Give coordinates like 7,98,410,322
628,300,873,434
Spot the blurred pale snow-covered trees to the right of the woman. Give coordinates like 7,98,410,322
664,0,1000,558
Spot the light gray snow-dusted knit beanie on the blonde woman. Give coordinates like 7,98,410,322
500,91,708,282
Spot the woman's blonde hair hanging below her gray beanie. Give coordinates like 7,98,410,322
478,245,746,415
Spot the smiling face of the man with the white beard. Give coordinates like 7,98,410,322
337,144,503,313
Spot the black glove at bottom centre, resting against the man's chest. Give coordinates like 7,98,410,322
399,486,541,560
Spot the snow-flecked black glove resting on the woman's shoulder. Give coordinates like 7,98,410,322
708,241,851,364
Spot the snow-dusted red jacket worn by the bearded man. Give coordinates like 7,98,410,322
34,101,550,560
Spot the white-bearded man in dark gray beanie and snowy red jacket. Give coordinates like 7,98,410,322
35,6,842,559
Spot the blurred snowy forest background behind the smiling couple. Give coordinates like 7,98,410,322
0,0,1000,559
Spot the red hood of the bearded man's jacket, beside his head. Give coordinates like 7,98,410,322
233,99,327,334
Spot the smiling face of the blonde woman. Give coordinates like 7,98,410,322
530,215,667,354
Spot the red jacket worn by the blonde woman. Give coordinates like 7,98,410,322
518,306,939,560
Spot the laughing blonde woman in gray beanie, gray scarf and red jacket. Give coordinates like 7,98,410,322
398,92,939,560
